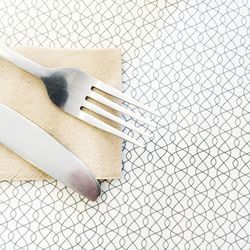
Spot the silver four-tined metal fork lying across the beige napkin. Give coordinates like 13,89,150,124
0,47,159,147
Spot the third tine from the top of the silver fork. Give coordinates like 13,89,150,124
83,101,151,138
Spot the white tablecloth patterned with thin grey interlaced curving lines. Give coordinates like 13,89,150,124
0,0,250,250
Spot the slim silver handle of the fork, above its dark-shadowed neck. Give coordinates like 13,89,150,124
0,47,49,78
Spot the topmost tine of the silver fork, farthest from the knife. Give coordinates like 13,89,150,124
93,80,161,117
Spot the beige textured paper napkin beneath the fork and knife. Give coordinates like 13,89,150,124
0,48,121,180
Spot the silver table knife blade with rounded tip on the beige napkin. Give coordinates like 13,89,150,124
0,103,100,201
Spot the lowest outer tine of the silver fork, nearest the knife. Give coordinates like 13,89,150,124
77,110,145,148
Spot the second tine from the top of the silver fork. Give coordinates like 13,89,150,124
88,91,157,127
